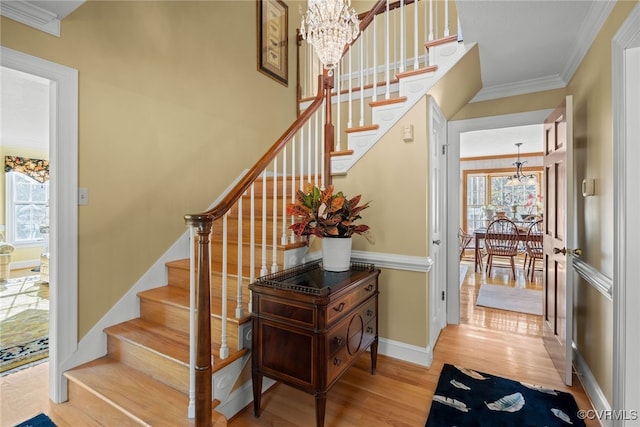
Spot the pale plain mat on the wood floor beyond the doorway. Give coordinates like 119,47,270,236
476,285,542,316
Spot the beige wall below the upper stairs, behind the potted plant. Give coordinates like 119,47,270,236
333,97,429,347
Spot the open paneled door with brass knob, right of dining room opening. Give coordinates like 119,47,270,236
543,96,579,385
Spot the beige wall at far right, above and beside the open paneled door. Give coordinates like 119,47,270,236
454,1,637,401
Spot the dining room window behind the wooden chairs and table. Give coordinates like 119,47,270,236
462,170,542,233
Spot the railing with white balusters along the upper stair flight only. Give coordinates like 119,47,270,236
298,0,457,152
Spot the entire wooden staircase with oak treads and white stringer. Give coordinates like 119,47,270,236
65,0,476,426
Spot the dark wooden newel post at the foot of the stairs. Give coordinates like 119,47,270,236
185,214,213,427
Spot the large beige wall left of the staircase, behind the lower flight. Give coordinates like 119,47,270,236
1,1,298,337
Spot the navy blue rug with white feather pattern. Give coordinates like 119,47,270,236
426,364,585,427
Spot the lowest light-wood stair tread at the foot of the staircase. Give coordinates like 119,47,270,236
64,356,226,426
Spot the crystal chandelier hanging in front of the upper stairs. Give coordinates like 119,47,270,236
300,0,360,76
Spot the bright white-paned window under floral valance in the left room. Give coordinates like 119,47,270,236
6,172,49,247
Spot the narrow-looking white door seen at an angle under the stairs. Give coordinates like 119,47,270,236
428,98,447,350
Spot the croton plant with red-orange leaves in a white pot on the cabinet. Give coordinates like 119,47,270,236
287,183,371,271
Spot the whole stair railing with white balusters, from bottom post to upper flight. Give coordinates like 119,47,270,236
185,0,458,426
